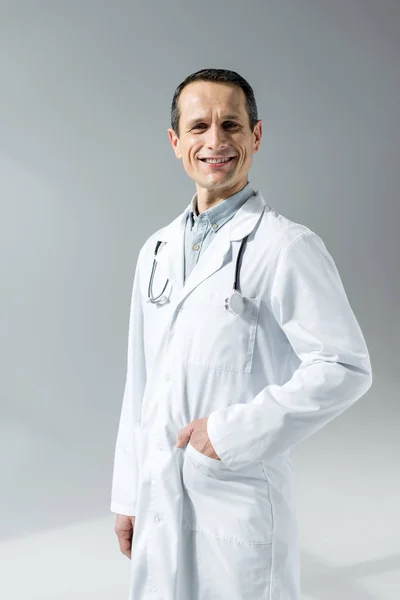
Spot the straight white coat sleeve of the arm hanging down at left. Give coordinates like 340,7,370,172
110,254,146,516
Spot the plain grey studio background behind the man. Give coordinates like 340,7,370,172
0,0,400,600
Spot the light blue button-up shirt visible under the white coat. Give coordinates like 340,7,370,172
184,182,254,281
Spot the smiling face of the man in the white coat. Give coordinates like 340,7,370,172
168,81,262,195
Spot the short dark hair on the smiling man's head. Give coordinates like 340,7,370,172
171,69,259,137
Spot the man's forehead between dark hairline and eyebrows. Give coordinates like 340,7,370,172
179,81,246,119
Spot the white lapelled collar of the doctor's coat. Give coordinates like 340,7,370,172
150,191,266,304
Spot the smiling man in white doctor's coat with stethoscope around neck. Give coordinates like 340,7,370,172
111,69,372,600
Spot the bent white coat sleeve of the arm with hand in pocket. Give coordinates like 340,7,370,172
207,229,372,470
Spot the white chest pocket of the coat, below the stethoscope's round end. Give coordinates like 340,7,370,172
178,293,261,373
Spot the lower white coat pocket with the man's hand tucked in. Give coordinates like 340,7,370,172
182,442,273,546
